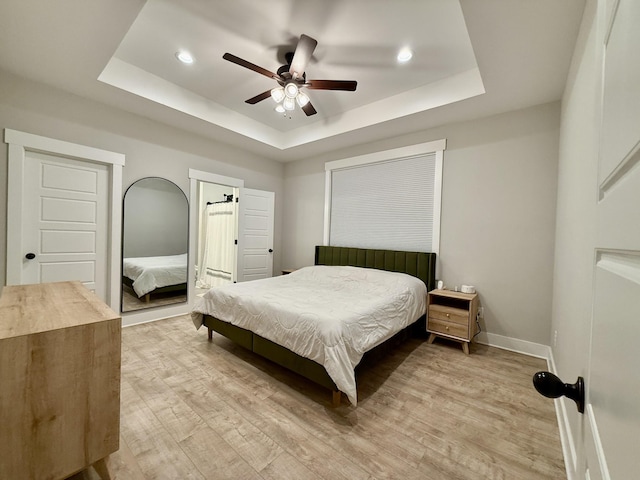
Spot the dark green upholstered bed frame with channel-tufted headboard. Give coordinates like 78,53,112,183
203,246,436,406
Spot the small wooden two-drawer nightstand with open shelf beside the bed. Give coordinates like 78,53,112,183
427,290,478,355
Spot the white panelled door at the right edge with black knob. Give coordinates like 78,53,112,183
579,0,640,480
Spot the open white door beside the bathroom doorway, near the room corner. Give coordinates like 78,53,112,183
237,188,275,282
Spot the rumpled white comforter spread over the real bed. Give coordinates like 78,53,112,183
191,266,426,405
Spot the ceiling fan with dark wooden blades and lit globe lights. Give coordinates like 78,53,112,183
222,34,358,116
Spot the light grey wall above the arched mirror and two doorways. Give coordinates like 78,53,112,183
0,71,283,314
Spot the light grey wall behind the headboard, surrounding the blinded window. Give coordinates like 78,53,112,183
282,102,560,345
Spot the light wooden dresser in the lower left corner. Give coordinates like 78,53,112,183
0,282,121,479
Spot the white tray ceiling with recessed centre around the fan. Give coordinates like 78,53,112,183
0,0,584,161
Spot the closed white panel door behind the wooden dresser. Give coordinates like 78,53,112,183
20,152,109,300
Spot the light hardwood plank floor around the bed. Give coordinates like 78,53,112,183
72,316,566,480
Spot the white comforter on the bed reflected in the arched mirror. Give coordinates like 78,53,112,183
122,253,187,297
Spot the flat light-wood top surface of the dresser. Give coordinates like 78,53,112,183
0,282,120,340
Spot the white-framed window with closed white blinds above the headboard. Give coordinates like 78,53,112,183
324,140,446,253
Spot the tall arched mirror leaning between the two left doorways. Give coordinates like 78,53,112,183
122,177,189,312
